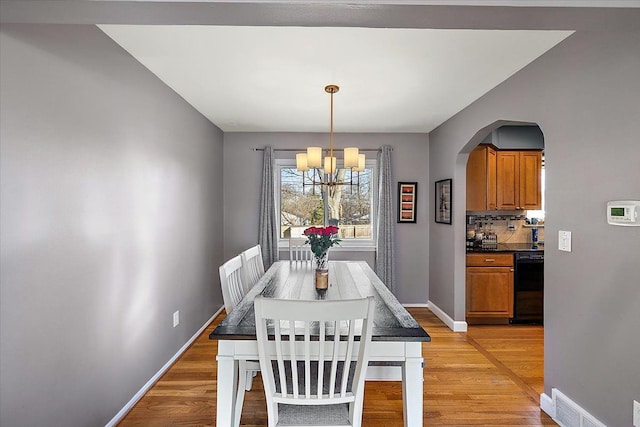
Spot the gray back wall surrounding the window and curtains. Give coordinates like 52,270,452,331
224,132,430,304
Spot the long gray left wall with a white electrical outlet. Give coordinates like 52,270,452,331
0,24,222,427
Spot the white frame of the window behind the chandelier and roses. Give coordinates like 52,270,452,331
274,159,378,252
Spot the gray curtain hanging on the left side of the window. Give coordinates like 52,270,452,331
258,146,278,269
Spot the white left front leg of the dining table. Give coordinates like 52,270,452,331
216,340,238,427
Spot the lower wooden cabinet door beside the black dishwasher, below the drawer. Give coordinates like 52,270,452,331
466,267,513,318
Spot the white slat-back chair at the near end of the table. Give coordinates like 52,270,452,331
254,296,374,427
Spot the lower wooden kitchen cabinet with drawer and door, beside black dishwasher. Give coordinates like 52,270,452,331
466,253,513,324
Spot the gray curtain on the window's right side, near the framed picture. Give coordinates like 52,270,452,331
376,145,395,294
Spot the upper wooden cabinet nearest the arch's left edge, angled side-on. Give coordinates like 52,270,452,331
467,145,497,211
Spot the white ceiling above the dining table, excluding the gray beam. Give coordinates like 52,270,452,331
99,25,571,132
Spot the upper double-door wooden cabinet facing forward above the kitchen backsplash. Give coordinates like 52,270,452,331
496,150,542,210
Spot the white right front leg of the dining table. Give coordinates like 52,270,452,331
402,342,424,427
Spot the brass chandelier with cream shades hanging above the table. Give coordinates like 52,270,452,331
296,85,366,189
